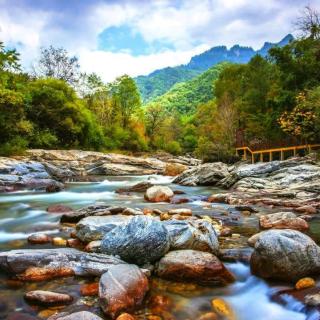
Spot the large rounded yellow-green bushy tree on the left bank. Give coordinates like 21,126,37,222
27,78,104,148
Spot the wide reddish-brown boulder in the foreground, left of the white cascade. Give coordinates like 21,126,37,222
155,250,234,285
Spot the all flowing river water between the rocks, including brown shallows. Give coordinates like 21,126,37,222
0,176,317,320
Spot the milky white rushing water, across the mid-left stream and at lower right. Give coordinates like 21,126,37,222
0,175,310,320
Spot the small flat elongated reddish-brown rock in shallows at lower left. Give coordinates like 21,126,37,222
24,290,73,306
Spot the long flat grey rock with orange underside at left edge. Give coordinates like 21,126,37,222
0,248,125,281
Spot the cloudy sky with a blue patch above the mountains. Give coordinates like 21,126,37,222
0,0,320,81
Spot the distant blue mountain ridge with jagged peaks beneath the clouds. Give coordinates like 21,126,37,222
135,34,293,103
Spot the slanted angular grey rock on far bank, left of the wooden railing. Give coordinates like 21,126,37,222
173,162,228,186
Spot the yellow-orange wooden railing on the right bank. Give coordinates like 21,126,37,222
236,144,320,163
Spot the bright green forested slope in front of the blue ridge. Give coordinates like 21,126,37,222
150,63,226,114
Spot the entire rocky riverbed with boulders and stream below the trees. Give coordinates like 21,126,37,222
0,150,320,320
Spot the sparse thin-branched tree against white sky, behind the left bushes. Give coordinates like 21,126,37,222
33,46,81,86
